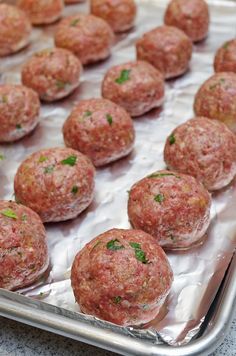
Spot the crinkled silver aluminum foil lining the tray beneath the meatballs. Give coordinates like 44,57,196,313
0,0,236,345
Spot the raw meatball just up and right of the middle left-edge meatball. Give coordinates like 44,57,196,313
22,48,82,101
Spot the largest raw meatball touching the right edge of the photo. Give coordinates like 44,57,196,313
164,117,236,190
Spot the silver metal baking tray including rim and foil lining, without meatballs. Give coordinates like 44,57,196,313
0,0,236,356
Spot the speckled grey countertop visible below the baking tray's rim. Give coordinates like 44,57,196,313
0,317,236,356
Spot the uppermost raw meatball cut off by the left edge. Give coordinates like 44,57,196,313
0,4,31,56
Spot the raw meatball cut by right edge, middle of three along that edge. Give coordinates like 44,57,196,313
194,72,236,133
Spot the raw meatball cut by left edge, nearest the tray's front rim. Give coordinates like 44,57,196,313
0,201,49,290
